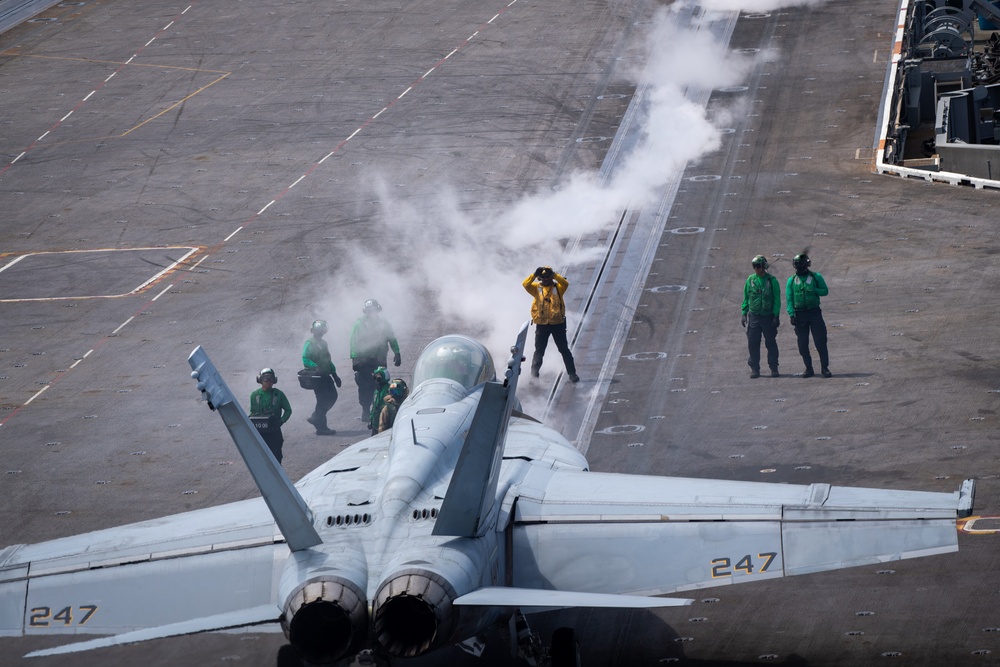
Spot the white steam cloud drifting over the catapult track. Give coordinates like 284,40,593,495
308,0,763,380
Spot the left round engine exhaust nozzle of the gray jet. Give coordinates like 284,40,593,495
281,576,368,664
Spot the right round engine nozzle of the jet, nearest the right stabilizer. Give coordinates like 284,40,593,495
374,569,457,658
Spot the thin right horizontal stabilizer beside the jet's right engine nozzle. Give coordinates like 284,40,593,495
453,587,694,609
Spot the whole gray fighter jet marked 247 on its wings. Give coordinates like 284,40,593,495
0,323,974,665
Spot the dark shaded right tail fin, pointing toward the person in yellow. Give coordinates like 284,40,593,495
434,322,530,537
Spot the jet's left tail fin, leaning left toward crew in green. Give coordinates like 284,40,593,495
188,345,323,551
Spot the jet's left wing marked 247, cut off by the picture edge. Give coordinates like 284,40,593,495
0,498,289,636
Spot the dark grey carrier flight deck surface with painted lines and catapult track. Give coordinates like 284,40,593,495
0,0,1000,667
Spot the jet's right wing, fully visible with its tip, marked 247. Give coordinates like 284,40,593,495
504,467,973,595
